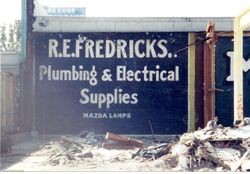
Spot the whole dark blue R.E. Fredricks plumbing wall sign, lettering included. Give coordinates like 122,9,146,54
35,32,188,134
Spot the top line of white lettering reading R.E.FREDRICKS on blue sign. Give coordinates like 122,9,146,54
48,36,177,58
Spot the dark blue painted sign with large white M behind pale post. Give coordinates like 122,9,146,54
215,37,250,126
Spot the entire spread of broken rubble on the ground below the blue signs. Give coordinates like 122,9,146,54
32,125,250,171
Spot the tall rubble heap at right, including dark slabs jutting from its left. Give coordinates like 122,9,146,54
135,125,250,171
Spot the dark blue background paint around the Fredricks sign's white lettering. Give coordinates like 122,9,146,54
35,32,188,134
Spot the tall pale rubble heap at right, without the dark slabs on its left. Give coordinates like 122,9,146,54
163,125,250,171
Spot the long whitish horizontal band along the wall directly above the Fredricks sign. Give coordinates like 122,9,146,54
33,17,233,32
